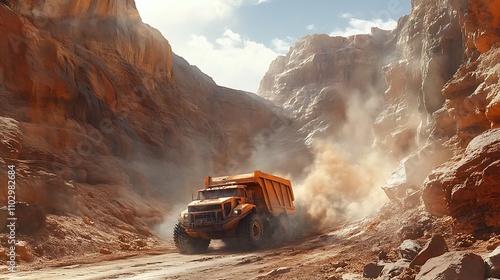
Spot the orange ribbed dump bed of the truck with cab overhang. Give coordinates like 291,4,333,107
205,170,296,216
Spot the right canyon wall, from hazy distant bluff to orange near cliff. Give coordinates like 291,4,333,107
259,0,500,233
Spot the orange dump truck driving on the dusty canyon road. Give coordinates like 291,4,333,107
174,170,296,254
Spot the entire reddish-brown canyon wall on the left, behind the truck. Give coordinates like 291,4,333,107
0,0,298,257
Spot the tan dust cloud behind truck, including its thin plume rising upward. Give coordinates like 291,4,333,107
292,89,396,235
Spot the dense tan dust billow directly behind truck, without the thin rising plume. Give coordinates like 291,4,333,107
292,140,393,235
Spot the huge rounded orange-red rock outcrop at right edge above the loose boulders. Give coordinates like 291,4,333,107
423,129,500,231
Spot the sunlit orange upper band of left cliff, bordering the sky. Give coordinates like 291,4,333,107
6,0,173,79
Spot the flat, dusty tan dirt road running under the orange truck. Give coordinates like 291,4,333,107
0,225,372,280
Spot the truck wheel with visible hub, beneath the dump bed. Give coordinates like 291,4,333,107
236,213,265,249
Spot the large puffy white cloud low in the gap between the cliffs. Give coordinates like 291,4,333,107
183,29,289,92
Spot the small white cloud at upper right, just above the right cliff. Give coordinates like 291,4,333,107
330,14,397,37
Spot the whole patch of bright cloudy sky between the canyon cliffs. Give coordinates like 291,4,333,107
135,0,411,92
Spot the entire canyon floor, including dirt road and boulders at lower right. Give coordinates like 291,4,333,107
0,200,500,280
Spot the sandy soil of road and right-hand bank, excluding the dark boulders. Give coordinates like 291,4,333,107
0,207,500,280
